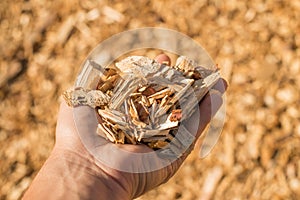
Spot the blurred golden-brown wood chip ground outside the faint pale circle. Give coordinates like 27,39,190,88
0,0,300,200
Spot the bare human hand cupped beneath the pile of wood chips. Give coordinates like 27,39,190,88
24,55,227,199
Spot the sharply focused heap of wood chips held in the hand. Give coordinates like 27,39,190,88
63,56,220,149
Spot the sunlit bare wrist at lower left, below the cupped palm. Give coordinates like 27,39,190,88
24,148,129,199
